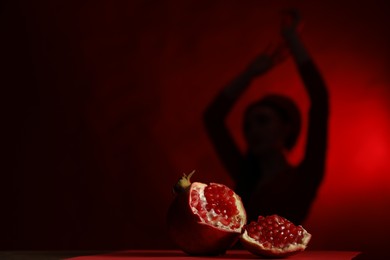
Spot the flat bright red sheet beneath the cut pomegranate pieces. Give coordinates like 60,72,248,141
68,250,359,260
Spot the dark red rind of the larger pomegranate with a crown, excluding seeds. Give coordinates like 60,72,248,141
167,182,246,255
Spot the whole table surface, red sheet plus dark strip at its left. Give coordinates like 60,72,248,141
0,250,359,260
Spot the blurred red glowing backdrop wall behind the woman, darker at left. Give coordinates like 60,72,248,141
0,0,390,256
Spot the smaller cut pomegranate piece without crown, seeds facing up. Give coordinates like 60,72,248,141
240,215,311,257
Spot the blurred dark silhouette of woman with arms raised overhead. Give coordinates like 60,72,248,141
204,11,328,224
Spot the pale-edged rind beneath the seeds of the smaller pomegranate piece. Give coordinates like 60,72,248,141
240,226,311,258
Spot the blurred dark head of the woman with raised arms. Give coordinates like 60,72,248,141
244,95,301,154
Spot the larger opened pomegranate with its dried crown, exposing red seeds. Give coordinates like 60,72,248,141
168,172,246,255
